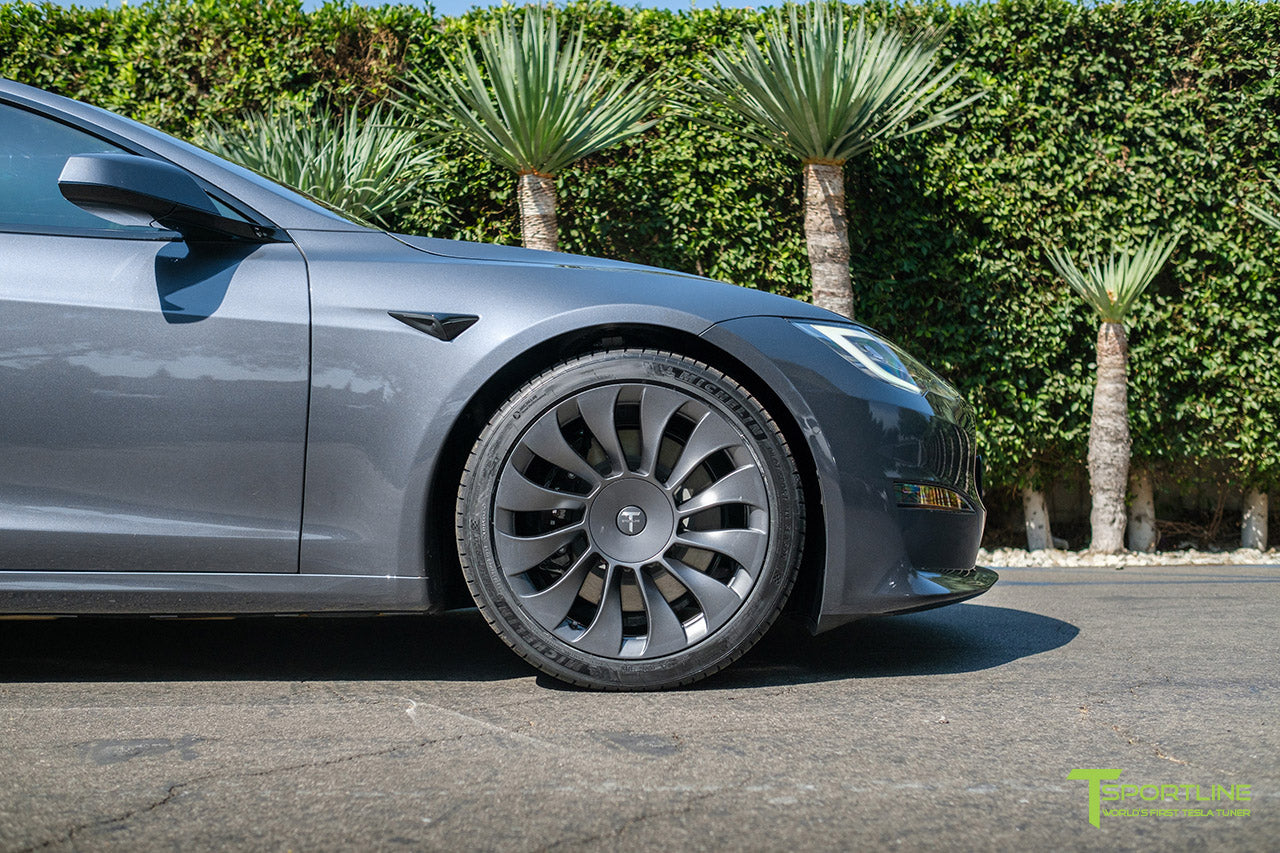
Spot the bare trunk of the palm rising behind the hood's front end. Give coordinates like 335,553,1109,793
804,163,854,316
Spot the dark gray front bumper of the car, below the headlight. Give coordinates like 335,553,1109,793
703,318,997,633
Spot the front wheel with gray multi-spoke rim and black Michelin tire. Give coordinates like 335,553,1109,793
458,350,804,689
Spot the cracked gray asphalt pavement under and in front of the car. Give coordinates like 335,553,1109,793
0,566,1280,852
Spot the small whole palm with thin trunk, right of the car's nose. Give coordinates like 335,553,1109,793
1048,234,1178,553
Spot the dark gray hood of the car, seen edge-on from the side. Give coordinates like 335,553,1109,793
392,234,847,323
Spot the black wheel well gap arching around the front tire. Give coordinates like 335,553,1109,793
424,318,826,615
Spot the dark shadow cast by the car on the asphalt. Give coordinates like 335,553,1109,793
0,605,1078,689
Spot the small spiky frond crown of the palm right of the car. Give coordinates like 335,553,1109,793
1046,234,1180,323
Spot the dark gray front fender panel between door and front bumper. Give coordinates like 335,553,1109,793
292,225,829,575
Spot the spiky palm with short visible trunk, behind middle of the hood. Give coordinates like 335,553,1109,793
401,6,658,251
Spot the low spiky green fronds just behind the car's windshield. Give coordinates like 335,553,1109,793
200,105,434,224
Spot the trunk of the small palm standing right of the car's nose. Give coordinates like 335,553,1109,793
1089,323,1129,553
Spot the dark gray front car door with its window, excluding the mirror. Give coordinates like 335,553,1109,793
0,101,310,573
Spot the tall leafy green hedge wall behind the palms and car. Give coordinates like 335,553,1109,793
0,0,1280,499
